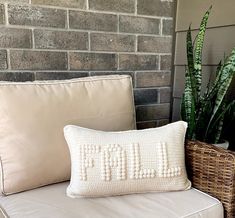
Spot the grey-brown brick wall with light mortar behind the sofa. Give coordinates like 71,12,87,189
0,0,174,128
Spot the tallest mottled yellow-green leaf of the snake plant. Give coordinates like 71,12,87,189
194,6,212,96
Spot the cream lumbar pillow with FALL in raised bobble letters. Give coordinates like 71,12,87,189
64,121,191,197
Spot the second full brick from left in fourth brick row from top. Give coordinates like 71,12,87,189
69,52,117,70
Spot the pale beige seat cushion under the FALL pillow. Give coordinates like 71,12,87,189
0,183,223,218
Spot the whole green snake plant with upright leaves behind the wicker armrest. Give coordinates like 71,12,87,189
181,7,235,143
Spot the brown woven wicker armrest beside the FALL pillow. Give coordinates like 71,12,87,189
186,141,235,218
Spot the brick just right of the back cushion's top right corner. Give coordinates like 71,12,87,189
136,72,171,87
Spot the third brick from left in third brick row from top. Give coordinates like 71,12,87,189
91,33,135,52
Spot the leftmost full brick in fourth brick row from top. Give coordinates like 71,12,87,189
10,50,67,70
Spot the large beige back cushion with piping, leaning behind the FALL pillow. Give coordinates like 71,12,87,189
0,75,135,194
